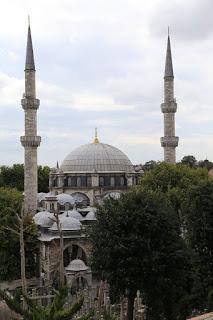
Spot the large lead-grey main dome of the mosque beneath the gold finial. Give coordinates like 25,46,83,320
61,143,134,172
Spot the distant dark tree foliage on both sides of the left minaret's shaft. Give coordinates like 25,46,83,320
0,164,50,192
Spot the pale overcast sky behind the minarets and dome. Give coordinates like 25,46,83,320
0,0,213,166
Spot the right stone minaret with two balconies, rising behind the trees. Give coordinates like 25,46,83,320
161,33,179,163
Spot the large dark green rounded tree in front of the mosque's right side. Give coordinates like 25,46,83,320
91,189,191,320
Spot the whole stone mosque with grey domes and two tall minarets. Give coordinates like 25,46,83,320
20,26,179,290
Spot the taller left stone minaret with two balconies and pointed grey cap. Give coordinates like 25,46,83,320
20,24,41,214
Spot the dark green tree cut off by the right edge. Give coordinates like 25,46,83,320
185,179,213,311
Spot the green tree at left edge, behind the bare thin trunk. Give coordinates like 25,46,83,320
0,188,38,280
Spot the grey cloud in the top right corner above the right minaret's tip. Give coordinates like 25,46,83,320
150,0,213,41
